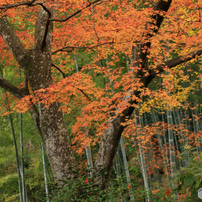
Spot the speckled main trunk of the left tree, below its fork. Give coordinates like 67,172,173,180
24,50,76,180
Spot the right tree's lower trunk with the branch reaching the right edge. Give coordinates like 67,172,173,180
95,47,202,188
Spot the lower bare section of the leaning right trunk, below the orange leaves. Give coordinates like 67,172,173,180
95,104,134,189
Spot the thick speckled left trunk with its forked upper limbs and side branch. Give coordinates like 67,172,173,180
0,9,76,181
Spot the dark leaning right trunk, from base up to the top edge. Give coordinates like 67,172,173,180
95,0,172,189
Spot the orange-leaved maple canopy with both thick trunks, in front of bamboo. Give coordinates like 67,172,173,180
0,0,202,193
